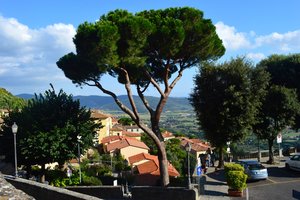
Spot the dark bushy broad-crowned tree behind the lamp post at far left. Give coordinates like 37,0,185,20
1,88,100,181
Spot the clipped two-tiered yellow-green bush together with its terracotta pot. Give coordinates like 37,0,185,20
224,163,247,196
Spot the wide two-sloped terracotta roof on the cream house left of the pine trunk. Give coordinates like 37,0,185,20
106,137,149,152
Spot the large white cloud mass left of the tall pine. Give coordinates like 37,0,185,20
0,15,76,93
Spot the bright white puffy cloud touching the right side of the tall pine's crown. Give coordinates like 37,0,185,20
215,22,255,50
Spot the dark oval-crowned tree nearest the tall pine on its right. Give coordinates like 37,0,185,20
190,58,269,167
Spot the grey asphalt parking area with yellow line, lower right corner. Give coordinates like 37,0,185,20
244,166,300,200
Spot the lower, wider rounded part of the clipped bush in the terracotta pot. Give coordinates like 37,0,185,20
226,171,247,191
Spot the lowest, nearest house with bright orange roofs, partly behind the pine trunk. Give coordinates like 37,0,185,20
128,153,180,186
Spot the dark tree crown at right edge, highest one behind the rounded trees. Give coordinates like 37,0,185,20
258,54,300,130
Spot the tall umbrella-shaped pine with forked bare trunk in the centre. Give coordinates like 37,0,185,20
57,7,225,186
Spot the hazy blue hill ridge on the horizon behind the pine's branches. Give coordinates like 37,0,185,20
17,94,193,113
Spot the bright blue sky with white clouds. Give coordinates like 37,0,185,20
0,0,300,97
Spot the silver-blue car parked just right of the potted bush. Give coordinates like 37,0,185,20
237,160,268,180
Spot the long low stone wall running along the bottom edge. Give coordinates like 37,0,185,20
0,173,199,200
